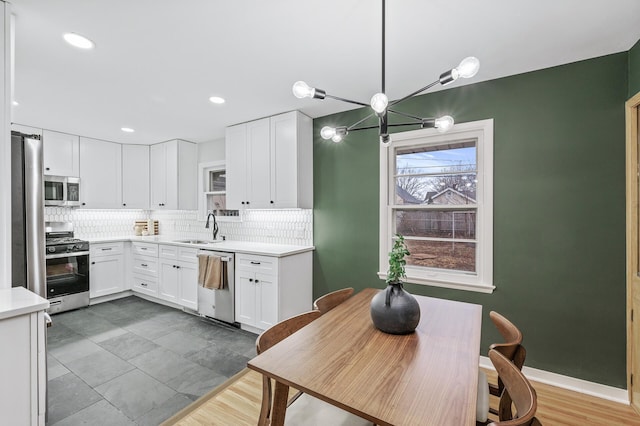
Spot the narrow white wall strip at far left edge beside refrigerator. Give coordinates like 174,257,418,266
0,1,11,289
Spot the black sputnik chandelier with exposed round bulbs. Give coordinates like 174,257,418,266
293,0,480,145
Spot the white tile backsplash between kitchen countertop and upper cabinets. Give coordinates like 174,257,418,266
44,207,313,245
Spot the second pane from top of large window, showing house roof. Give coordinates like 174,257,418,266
394,172,478,205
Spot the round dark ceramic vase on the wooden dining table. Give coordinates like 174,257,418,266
371,282,420,334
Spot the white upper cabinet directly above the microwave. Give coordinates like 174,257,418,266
42,130,80,177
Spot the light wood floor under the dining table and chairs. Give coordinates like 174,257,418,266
163,369,640,426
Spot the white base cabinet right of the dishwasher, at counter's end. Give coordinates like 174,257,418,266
235,252,313,333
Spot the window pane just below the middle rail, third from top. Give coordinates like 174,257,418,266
395,210,476,240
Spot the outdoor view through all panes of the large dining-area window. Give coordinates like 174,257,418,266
394,140,478,272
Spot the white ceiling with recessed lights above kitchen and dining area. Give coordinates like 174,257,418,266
12,0,640,144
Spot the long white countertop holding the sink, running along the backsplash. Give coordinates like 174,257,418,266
84,235,315,257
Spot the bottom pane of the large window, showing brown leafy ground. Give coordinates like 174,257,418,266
405,240,476,272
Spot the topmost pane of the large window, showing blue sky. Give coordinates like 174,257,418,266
395,141,478,175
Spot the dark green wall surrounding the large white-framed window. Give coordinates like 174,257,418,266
313,52,629,388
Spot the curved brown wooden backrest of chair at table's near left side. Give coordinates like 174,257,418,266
256,311,322,426
